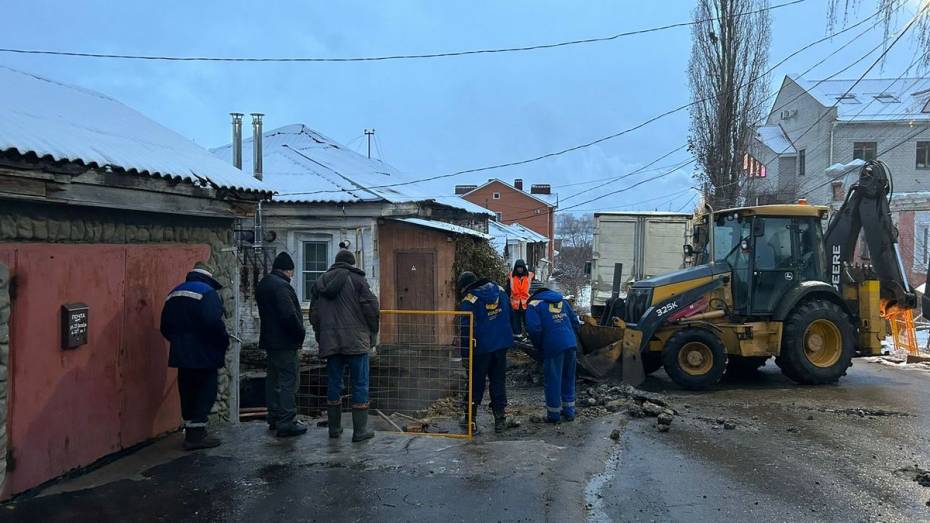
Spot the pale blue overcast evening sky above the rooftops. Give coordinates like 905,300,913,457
0,0,918,212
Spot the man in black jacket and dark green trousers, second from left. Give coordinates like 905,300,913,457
255,252,307,437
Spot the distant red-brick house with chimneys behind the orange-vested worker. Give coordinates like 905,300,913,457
455,178,559,277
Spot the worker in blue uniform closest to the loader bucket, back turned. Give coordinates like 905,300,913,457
526,288,581,423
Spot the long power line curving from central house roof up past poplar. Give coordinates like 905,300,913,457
279,6,881,196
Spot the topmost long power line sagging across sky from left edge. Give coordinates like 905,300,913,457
0,0,807,63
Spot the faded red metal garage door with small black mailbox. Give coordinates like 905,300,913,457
0,244,209,495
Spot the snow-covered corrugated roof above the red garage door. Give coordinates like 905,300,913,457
0,66,268,192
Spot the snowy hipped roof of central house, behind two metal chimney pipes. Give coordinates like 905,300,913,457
212,124,487,214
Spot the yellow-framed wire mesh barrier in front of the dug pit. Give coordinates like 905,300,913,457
297,310,473,439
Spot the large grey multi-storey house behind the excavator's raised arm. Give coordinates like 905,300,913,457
745,76,930,286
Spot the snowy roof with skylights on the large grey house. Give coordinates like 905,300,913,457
791,77,930,122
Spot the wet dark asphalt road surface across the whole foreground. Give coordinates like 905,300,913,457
0,362,930,522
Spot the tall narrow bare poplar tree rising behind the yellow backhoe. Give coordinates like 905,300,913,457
688,0,772,209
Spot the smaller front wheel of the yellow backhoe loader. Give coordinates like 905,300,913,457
662,328,727,390
